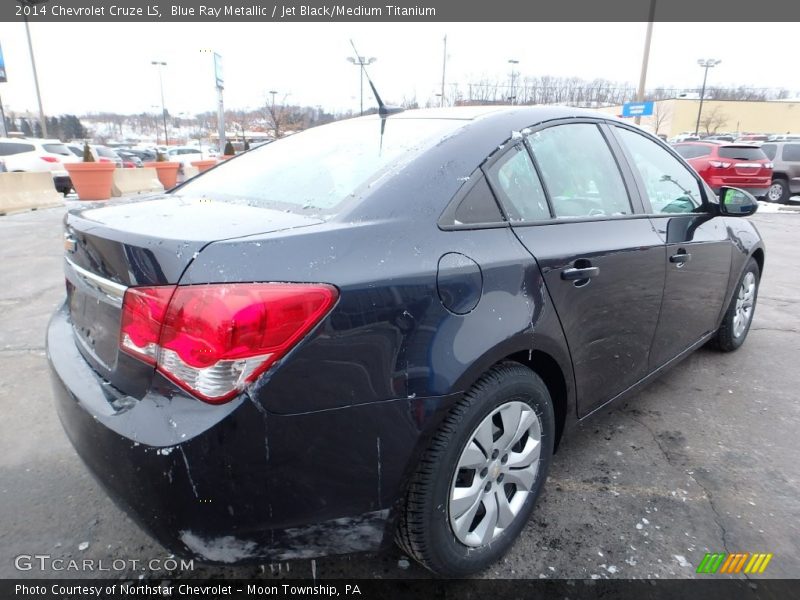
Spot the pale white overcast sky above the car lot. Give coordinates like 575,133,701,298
0,23,800,115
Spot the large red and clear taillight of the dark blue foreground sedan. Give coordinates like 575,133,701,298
120,283,338,404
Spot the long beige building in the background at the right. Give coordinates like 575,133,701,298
600,98,800,137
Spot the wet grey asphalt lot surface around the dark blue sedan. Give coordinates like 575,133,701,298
0,207,800,579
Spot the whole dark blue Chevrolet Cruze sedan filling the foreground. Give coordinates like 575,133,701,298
47,108,764,576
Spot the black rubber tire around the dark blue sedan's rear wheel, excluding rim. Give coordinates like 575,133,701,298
396,361,555,577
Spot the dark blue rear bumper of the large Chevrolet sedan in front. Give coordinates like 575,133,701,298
47,308,455,564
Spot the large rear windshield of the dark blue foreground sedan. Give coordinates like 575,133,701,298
177,117,464,213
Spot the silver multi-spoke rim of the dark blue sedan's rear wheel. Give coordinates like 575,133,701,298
448,401,542,547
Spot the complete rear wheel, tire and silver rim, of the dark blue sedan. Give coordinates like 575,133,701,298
397,362,555,577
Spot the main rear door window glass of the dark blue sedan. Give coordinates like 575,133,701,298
528,123,633,218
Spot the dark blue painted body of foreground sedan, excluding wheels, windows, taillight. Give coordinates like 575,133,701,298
47,108,764,563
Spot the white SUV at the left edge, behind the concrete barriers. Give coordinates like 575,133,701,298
0,138,80,195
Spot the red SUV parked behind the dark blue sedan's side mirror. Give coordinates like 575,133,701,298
674,142,772,198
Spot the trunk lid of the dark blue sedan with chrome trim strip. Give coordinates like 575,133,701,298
64,197,322,397
